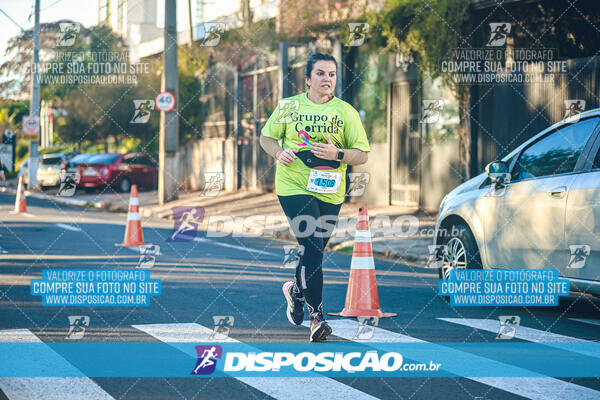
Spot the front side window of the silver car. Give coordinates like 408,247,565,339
512,118,598,181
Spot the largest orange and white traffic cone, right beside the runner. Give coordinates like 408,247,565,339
328,206,397,318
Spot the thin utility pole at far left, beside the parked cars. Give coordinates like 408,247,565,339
28,0,40,188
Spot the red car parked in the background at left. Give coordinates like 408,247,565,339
77,153,158,192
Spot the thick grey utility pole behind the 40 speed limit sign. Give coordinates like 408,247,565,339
158,0,179,204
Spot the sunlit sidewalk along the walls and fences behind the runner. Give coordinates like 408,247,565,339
0,182,437,264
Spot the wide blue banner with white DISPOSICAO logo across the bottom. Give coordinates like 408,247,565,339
0,342,600,378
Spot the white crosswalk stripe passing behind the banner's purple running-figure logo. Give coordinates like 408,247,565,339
132,323,377,400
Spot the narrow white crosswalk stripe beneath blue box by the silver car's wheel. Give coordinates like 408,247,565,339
438,318,600,357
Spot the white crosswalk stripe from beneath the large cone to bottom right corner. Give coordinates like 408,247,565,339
310,319,600,400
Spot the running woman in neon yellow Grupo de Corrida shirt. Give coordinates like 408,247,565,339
260,53,371,342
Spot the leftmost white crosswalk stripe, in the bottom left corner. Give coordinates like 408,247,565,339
0,329,114,400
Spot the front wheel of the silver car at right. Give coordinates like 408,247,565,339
438,225,483,279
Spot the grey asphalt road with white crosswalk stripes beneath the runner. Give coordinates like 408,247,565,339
0,194,600,400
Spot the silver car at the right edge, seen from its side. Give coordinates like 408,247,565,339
435,109,600,295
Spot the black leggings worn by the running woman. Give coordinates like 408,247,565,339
278,194,342,313
